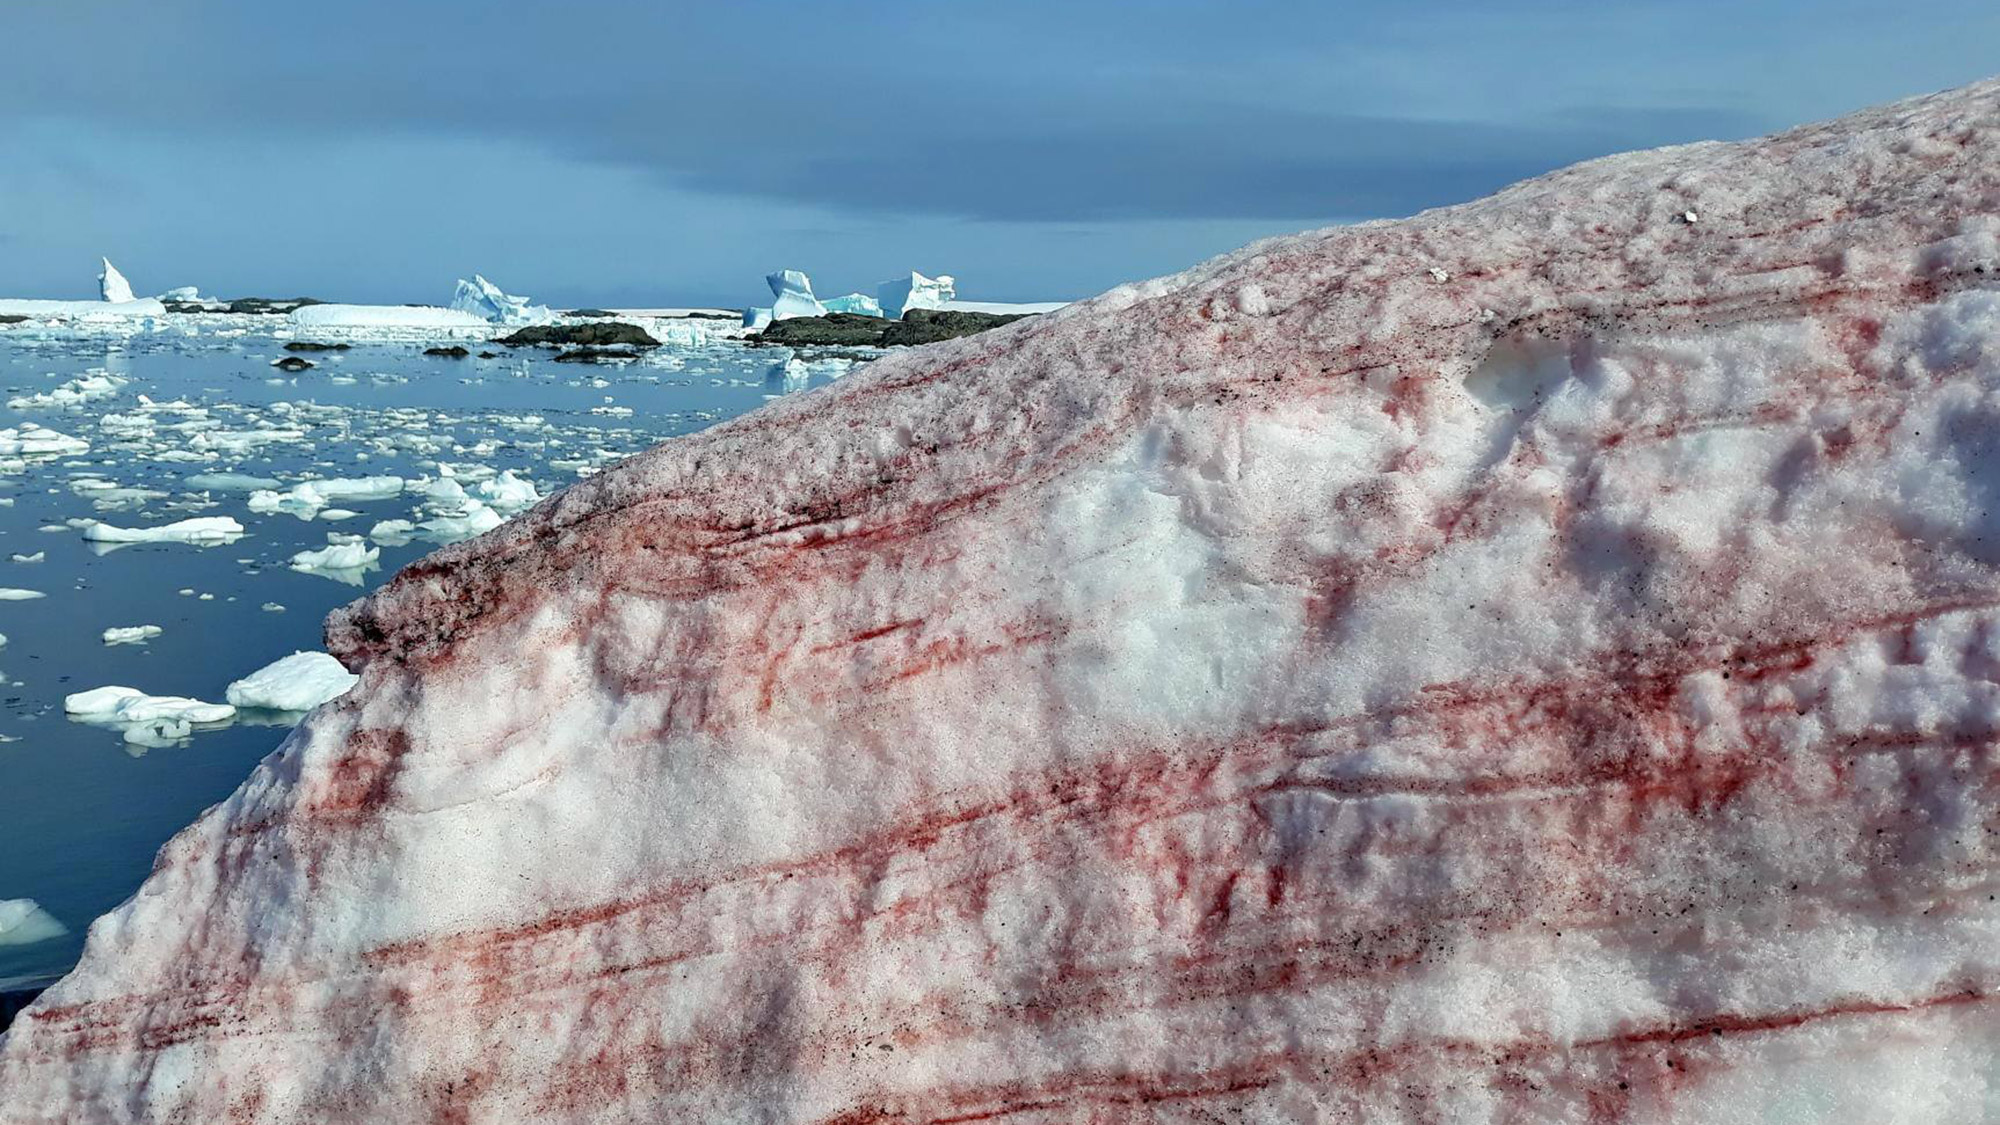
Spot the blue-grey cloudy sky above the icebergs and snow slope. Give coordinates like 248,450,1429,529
0,0,2000,306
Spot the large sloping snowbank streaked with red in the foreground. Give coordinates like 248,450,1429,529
0,84,2000,1125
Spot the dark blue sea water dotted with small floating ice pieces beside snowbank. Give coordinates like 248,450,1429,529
0,328,844,989
